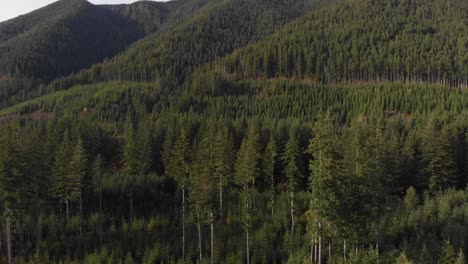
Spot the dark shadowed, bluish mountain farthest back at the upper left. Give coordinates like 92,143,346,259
0,0,213,81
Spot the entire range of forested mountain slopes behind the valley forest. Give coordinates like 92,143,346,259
0,0,468,108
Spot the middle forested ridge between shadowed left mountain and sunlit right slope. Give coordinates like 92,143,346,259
54,0,333,87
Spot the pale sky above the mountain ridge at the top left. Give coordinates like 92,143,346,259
0,0,167,22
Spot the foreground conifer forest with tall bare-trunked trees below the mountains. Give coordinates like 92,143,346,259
0,80,468,263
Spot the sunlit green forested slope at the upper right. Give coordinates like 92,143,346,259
202,0,468,86
